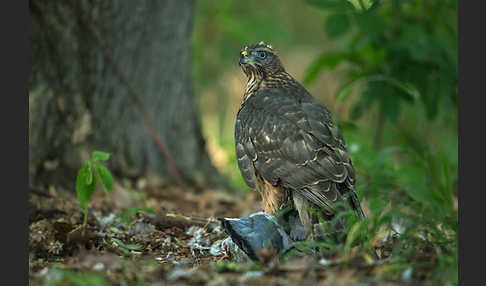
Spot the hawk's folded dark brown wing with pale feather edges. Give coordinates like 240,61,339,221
235,90,362,216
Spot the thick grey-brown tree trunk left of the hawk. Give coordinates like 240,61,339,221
29,0,221,191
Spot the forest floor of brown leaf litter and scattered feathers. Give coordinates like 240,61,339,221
29,180,433,286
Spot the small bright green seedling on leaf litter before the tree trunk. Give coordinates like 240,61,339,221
76,151,113,225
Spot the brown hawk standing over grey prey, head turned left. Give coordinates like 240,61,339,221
235,42,364,239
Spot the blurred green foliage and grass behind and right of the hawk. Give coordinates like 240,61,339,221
192,0,458,285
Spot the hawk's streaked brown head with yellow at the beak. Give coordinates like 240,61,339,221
239,42,284,77
